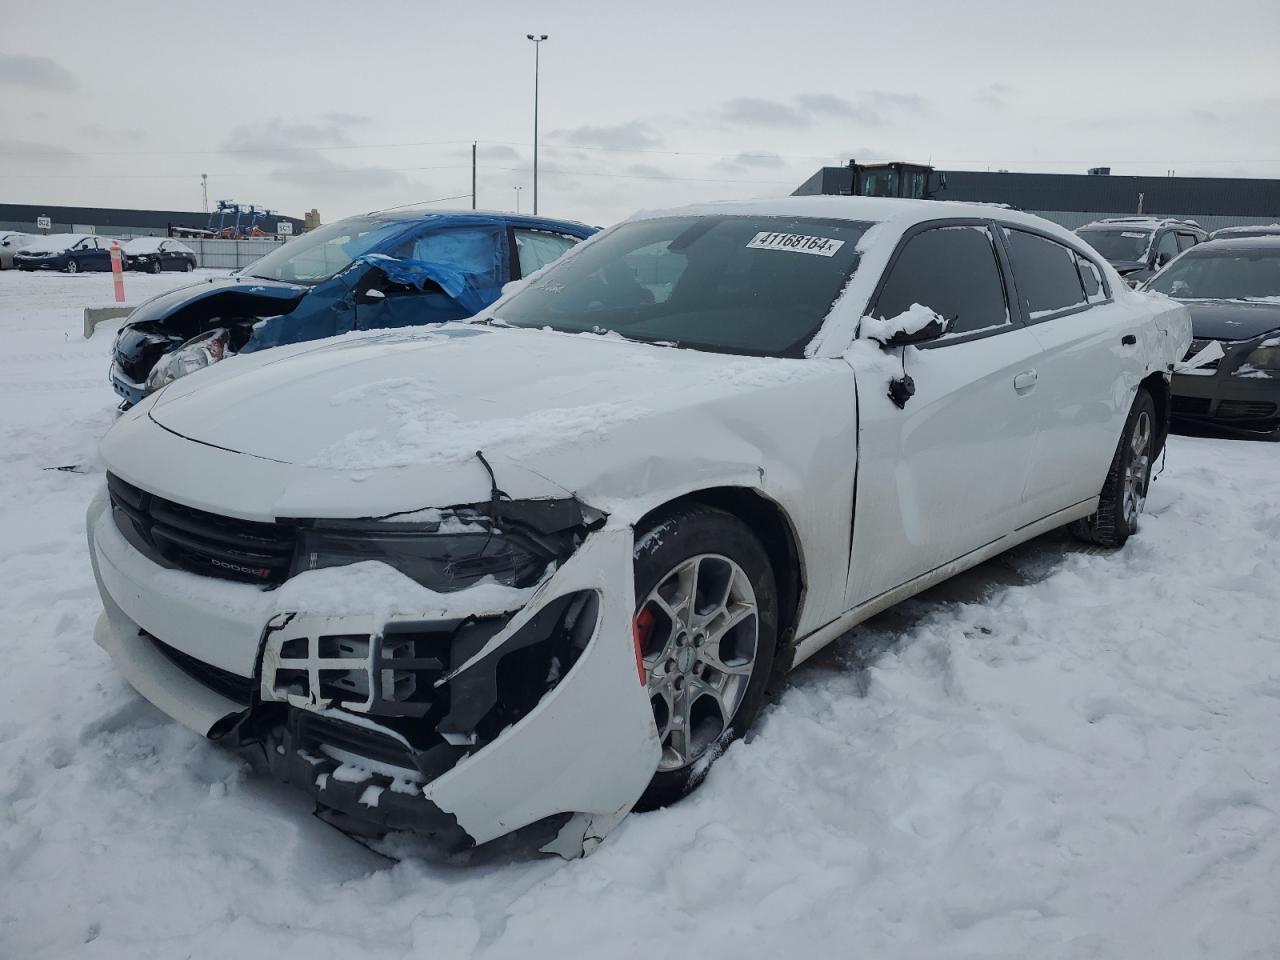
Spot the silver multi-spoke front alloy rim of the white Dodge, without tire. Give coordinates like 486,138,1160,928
635,553,760,772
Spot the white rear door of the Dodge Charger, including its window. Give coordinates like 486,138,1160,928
1001,227,1157,520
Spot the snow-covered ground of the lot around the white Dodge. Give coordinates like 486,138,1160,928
0,271,1280,960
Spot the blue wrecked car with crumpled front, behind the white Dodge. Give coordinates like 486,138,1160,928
110,209,596,408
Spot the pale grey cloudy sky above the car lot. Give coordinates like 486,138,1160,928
0,0,1280,224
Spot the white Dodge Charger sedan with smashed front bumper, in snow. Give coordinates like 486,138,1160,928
88,197,1190,856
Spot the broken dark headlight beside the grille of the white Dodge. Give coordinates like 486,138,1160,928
293,517,557,593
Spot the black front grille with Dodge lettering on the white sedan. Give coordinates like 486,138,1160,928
106,474,297,586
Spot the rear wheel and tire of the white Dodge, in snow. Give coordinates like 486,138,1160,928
1070,389,1156,547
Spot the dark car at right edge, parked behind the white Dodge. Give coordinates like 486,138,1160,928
1146,236,1280,438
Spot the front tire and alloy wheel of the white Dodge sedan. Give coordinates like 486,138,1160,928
635,506,778,809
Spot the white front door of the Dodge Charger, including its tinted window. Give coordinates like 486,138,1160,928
846,220,1041,607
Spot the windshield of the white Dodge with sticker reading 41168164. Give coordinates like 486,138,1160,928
488,216,870,356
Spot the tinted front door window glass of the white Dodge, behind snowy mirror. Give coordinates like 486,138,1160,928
873,227,1008,334
